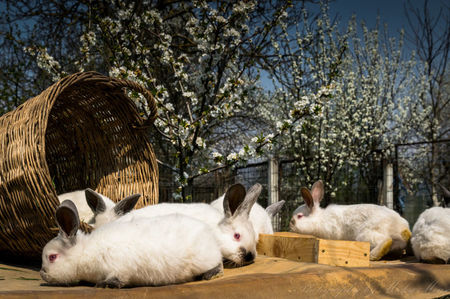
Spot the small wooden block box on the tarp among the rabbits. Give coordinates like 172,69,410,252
257,232,370,267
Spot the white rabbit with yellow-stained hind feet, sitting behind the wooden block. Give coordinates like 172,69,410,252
290,181,411,260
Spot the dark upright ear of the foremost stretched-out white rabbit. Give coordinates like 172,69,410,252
56,199,80,238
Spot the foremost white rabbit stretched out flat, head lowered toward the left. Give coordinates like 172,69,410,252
40,200,223,288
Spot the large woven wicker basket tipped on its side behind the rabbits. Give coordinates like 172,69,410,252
0,72,158,256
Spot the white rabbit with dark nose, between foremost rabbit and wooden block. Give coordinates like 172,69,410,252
87,184,262,266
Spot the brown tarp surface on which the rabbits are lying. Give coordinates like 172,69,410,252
0,256,450,299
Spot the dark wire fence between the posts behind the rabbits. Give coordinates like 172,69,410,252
160,141,450,231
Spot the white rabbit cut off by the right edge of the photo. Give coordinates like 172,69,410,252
411,207,450,263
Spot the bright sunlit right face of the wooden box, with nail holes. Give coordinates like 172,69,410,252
316,239,370,267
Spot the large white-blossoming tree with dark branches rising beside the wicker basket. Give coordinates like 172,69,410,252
16,0,316,199
